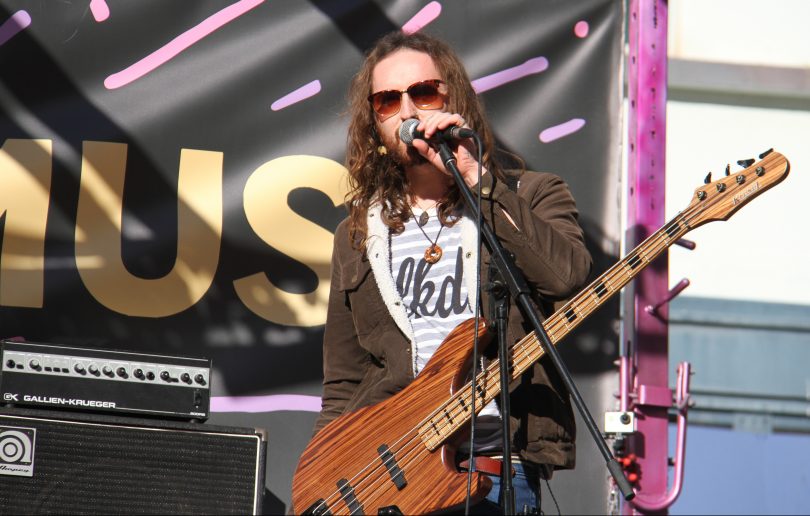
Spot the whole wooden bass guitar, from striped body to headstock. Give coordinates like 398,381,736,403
292,150,790,514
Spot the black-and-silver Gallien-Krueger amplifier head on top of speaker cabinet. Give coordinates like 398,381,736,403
0,340,211,421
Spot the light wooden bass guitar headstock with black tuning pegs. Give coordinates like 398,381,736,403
684,149,790,228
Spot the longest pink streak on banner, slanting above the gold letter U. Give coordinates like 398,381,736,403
104,0,264,90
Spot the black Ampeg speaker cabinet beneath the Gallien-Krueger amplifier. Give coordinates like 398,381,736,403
0,408,267,514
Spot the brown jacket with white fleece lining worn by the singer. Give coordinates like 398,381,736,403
315,172,591,468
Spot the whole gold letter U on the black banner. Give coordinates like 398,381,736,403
76,142,223,317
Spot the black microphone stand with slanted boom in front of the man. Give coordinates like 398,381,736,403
436,135,635,514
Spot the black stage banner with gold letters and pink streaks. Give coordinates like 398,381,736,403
0,0,624,508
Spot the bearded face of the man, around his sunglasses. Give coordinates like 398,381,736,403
371,49,447,166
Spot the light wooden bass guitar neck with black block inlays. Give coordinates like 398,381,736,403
419,213,692,450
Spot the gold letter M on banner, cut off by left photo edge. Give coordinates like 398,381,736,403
0,140,53,308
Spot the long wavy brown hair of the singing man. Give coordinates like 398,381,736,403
346,31,503,249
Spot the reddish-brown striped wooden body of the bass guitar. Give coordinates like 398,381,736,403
292,320,492,514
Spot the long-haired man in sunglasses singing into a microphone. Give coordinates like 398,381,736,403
316,32,591,513
